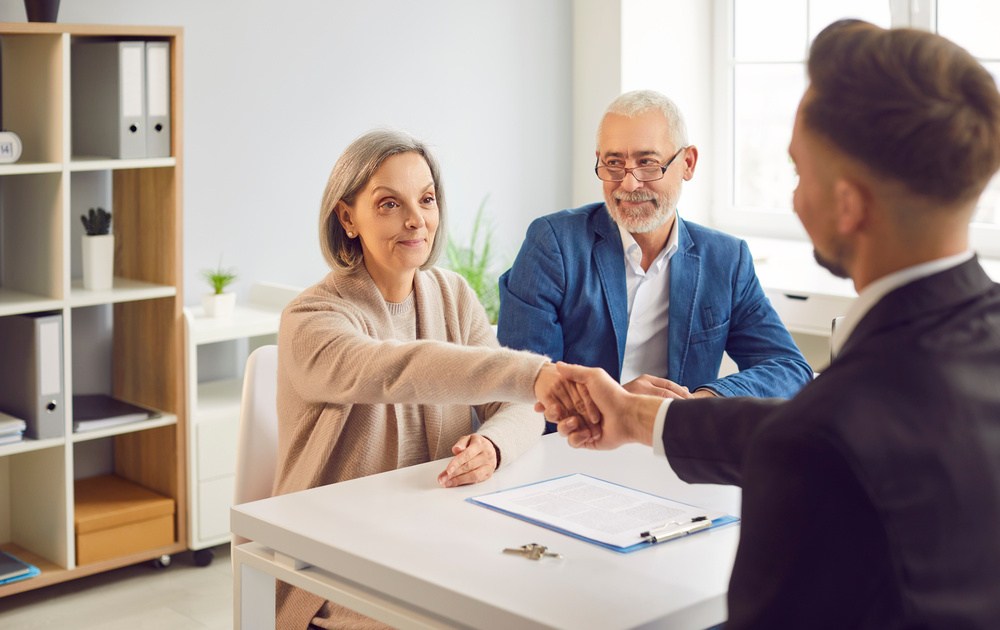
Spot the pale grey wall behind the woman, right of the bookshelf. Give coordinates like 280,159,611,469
0,0,572,304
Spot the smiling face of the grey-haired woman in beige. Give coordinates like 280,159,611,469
338,152,440,301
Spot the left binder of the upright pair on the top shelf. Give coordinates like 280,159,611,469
70,40,146,158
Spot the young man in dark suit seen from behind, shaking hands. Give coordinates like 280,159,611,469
546,21,1000,630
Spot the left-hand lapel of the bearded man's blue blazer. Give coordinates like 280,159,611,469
591,206,628,375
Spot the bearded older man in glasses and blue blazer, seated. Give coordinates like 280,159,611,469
498,91,812,434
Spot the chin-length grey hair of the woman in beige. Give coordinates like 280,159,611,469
319,129,446,269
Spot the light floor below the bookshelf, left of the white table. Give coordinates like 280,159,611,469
0,545,233,630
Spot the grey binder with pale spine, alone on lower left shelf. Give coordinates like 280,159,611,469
0,313,66,440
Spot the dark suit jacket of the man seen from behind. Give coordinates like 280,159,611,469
663,260,1000,630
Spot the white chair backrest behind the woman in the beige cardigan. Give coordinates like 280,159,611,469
233,345,278,545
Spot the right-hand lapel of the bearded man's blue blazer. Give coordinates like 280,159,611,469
666,220,701,383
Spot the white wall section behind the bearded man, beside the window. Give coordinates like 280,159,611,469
573,0,715,223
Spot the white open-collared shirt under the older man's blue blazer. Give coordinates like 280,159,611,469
618,219,677,383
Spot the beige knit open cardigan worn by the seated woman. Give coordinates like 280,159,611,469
274,267,547,628
